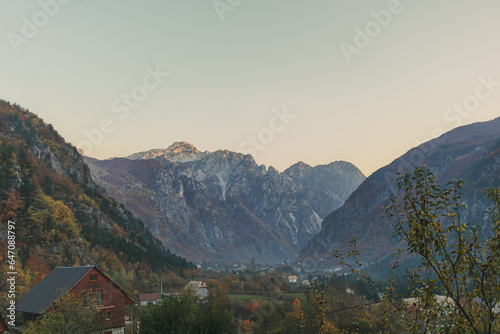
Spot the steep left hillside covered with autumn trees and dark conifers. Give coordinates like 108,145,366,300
0,100,191,308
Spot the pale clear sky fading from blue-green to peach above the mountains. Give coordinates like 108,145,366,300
0,0,500,176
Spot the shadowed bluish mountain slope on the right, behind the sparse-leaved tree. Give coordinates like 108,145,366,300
299,118,500,265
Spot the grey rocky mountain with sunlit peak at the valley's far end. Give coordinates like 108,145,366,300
86,142,364,263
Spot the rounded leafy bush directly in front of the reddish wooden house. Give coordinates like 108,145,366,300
23,293,103,334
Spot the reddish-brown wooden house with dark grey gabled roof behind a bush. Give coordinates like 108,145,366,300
16,266,135,334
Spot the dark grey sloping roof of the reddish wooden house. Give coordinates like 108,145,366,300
16,266,94,314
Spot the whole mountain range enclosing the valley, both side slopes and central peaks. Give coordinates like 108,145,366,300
0,100,500,274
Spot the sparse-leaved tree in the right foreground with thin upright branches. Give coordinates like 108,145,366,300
334,167,500,333
